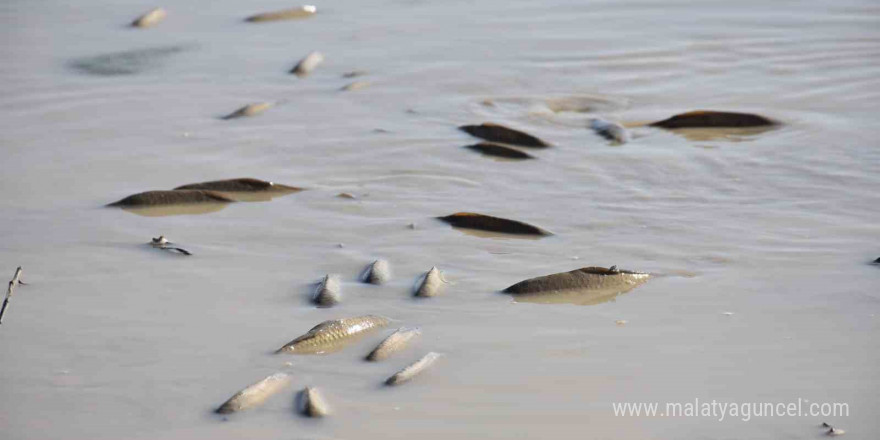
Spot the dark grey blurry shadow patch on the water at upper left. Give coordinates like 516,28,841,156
69,46,190,76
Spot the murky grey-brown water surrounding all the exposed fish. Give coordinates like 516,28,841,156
0,0,880,439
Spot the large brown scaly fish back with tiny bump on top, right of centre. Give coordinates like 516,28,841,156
503,266,651,305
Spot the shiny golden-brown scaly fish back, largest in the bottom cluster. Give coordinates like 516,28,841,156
276,315,390,354
